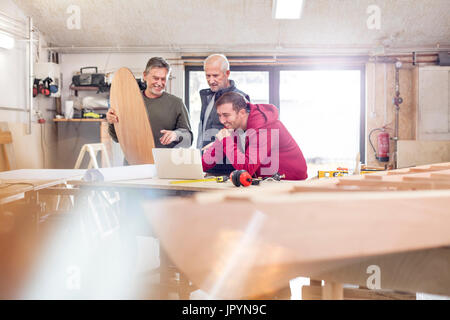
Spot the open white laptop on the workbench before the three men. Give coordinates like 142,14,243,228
152,148,205,179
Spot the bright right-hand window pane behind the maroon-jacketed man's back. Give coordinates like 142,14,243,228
279,70,361,176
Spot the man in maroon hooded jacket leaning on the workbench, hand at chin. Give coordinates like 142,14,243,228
202,92,308,180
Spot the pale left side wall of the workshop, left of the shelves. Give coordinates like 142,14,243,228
0,0,56,169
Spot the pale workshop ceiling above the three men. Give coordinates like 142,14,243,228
9,0,450,52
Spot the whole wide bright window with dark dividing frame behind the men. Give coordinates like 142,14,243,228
185,62,365,177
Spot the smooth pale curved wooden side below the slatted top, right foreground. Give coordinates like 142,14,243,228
147,190,450,298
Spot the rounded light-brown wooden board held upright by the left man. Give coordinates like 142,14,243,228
110,68,155,165
